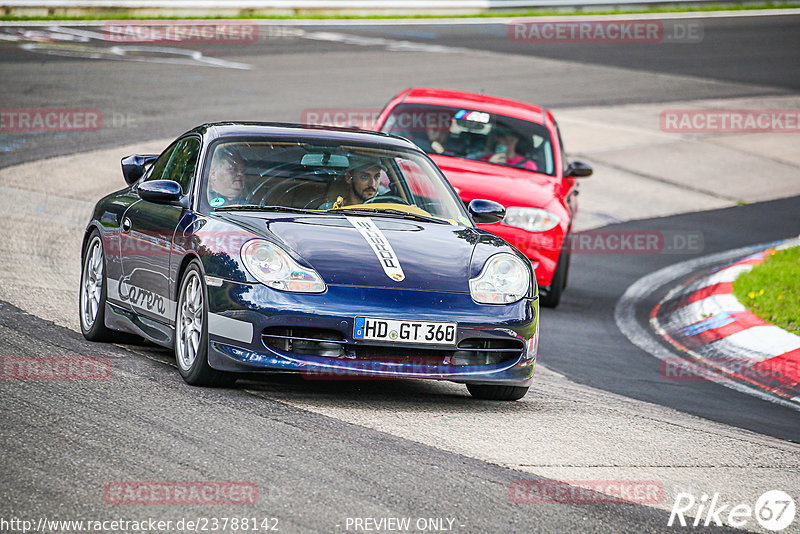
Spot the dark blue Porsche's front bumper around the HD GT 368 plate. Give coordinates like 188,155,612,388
208,281,539,386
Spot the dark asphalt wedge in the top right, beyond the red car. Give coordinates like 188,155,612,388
328,15,800,92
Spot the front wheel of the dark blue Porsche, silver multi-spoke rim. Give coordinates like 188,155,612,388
175,260,236,387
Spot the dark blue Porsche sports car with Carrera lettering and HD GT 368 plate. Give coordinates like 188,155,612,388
80,123,539,400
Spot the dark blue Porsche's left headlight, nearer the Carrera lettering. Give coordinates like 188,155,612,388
242,239,325,293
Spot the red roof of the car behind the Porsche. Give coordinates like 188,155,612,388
403,87,545,124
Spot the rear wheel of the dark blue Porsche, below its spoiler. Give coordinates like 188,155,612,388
78,230,112,341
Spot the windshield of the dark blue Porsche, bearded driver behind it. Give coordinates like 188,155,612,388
203,138,472,226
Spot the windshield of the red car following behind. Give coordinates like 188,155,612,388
381,104,555,176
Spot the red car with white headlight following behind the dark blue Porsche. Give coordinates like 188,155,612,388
375,88,592,308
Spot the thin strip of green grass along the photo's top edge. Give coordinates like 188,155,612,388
0,2,800,22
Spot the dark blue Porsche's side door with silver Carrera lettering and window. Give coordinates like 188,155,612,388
119,136,201,330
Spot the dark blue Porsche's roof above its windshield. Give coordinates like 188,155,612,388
184,121,420,152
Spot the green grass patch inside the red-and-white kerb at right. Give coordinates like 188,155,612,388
733,247,800,335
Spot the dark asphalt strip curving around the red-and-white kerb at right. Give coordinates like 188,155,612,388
552,197,800,442
